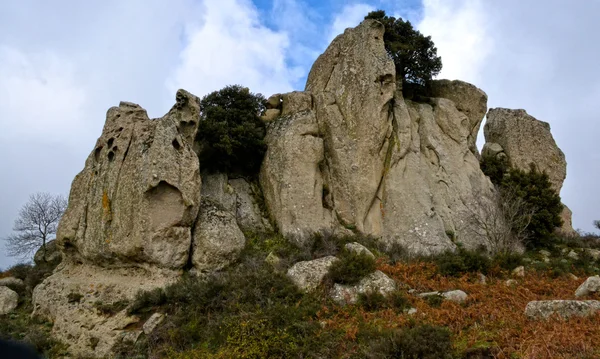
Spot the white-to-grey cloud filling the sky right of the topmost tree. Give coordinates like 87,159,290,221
418,0,600,231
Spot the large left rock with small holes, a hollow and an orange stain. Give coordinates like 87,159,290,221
57,91,200,269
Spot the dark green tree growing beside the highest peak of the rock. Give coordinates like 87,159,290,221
365,10,442,85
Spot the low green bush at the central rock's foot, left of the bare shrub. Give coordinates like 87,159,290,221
432,247,491,277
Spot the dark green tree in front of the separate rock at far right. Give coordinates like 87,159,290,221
500,164,563,249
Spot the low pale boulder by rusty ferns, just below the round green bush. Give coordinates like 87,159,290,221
331,271,396,304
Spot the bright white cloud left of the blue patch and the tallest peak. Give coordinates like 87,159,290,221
168,0,301,96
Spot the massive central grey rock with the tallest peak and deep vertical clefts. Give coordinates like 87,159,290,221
261,20,493,253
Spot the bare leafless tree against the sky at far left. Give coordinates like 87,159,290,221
4,193,67,260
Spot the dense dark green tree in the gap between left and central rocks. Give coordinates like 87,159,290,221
196,85,266,175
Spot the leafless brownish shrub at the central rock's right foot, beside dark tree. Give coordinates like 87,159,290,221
469,189,535,254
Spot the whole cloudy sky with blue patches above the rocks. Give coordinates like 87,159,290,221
0,0,600,268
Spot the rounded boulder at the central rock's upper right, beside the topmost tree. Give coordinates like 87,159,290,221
431,80,487,157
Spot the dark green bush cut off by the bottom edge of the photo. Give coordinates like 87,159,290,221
368,324,452,359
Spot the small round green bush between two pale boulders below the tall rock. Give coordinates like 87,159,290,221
328,249,376,285
